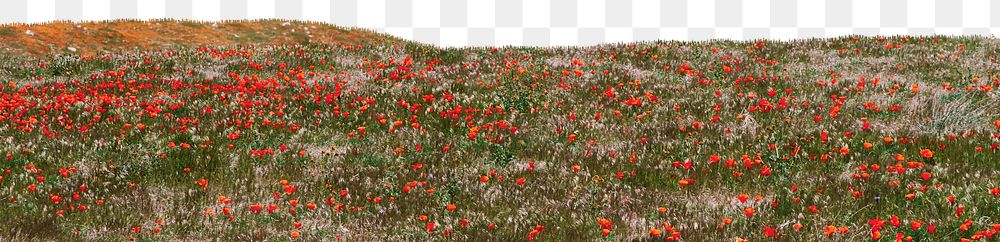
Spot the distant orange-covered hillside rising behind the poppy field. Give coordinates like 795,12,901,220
0,20,404,56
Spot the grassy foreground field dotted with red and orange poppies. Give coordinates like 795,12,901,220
0,27,1000,241
